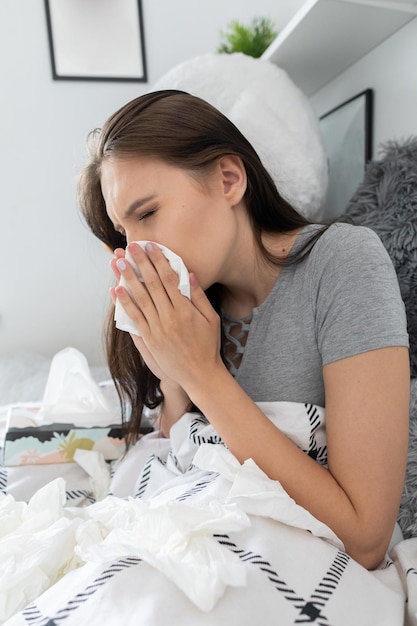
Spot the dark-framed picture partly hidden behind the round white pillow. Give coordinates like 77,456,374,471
319,89,373,221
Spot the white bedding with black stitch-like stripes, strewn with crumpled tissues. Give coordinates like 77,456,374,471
0,402,417,626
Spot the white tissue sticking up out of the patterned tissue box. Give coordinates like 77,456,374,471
37,348,115,428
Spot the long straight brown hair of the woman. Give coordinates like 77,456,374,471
78,90,322,445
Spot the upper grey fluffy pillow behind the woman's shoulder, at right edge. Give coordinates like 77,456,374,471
342,137,417,377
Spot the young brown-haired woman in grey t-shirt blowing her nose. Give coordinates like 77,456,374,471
79,91,410,568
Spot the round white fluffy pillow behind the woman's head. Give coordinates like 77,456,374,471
152,53,328,221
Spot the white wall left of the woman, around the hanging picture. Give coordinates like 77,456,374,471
0,0,303,364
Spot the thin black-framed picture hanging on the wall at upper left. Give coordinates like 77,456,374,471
44,0,147,82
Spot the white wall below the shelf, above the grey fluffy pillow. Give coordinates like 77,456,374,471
311,18,417,152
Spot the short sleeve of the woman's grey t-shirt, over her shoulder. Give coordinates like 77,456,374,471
310,224,409,365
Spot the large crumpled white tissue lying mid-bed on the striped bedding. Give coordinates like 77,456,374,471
76,496,250,612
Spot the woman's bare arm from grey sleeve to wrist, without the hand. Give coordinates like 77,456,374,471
188,348,410,569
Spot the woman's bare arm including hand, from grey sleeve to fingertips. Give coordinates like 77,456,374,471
116,241,410,568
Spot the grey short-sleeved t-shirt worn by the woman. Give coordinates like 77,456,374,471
232,223,408,406
